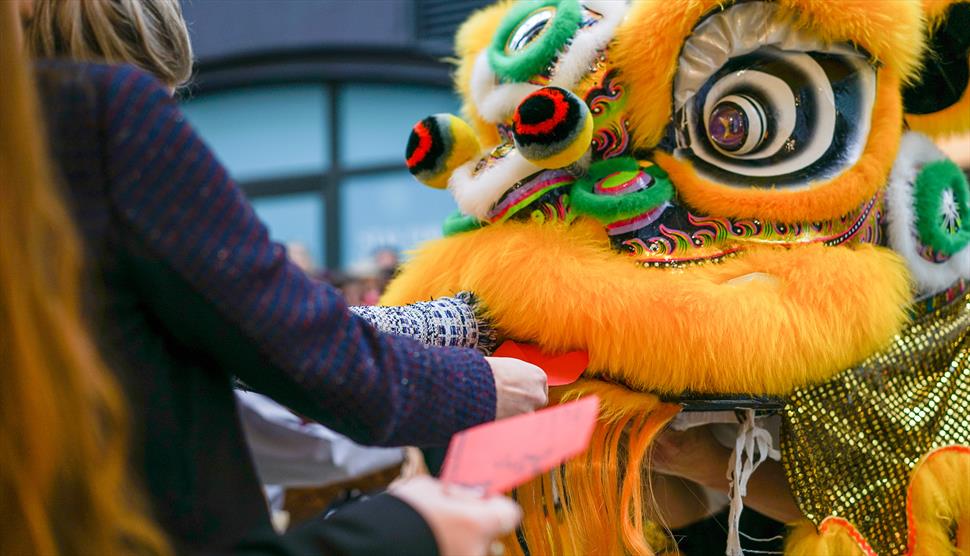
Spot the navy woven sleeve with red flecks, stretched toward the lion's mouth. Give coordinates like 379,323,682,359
99,67,495,445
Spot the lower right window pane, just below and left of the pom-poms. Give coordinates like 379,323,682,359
340,170,456,268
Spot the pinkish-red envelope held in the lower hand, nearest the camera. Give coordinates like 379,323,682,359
441,396,599,494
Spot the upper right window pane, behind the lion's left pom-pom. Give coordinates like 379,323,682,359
338,84,460,167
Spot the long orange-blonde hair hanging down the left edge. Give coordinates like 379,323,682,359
0,2,170,555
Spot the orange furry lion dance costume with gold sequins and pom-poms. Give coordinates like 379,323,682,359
384,0,970,556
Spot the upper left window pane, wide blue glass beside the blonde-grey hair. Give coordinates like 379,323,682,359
182,84,330,182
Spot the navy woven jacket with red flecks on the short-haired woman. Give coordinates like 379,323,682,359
35,61,495,551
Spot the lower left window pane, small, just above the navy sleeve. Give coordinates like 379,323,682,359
252,192,325,268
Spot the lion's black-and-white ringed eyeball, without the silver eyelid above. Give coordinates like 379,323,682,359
677,47,875,186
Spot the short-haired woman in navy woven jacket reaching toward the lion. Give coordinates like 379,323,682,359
9,0,545,556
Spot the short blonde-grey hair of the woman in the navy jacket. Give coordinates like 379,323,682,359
27,0,192,89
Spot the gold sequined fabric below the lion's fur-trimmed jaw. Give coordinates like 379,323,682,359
781,289,970,555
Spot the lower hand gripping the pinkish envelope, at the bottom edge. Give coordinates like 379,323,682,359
388,476,522,556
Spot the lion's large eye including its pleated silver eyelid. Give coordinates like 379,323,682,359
671,2,876,188
